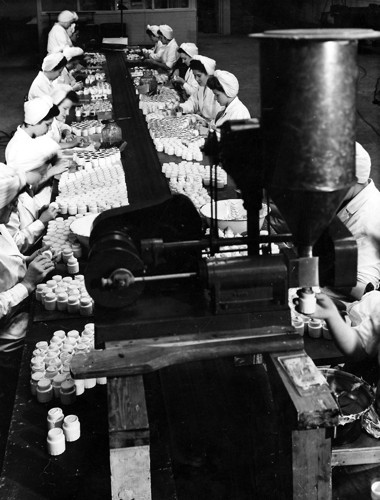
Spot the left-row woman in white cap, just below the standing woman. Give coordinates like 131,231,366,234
28,52,67,100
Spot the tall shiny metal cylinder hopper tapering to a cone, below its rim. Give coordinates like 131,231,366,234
261,30,357,247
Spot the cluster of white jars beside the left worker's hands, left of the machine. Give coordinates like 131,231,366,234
36,274,94,316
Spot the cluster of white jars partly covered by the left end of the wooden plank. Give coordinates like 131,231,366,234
30,323,107,405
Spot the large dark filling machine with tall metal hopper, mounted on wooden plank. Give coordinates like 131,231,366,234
72,30,379,498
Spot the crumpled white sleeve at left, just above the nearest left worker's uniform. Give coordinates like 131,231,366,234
6,193,45,253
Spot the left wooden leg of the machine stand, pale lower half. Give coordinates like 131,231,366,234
107,376,152,500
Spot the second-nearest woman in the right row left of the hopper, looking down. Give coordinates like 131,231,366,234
179,55,222,122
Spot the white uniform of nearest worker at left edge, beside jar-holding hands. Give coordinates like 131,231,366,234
0,224,28,318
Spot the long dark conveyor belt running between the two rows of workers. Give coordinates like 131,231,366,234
106,52,170,207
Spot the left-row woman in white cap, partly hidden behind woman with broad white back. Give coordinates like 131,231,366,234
48,85,80,149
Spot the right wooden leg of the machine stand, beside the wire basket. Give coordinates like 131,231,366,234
292,429,331,500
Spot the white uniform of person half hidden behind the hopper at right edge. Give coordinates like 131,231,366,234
337,179,380,288
